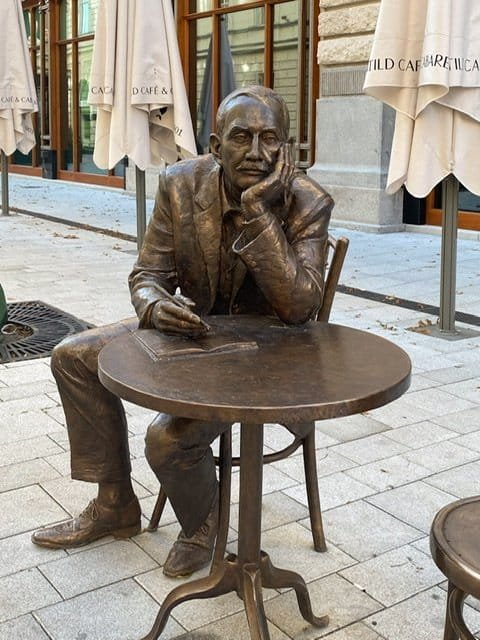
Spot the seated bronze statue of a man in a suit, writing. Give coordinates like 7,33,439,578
32,86,333,576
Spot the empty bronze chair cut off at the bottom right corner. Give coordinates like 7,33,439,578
430,496,480,640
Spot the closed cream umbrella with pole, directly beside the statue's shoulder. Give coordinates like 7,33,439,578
89,0,196,247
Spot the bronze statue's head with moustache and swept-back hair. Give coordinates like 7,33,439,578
210,85,290,199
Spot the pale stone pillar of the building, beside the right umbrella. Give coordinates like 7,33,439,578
308,0,404,232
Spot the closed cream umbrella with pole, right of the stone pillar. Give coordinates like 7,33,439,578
364,0,480,332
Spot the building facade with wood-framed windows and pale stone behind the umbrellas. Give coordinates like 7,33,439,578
11,0,480,231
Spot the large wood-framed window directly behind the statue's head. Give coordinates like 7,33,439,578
177,0,318,168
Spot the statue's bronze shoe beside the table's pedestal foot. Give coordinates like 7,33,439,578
163,491,218,578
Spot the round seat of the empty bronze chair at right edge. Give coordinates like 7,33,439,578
430,496,480,599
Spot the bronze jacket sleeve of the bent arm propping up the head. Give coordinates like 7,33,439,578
233,176,333,324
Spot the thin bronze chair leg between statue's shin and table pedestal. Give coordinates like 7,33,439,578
210,427,232,573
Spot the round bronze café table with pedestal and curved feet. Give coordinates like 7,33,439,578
99,316,411,640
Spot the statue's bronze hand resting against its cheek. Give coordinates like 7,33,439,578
241,142,295,221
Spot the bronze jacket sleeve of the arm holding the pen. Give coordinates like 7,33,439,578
128,173,177,328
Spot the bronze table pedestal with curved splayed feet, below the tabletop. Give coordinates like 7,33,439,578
142,424,328,640
